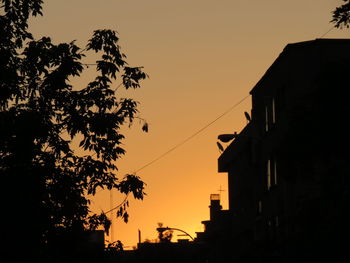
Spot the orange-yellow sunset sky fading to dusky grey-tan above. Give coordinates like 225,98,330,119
30,0,350,247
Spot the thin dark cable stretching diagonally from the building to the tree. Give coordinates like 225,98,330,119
135,95,250,174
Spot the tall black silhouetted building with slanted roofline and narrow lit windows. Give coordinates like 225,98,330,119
218,39,350,262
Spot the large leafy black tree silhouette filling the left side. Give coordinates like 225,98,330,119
0,0,148,261
